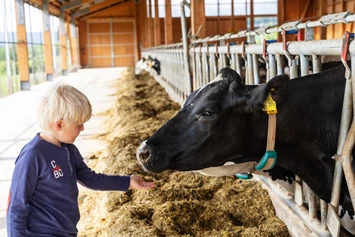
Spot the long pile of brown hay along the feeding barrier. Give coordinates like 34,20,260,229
78,68,289,237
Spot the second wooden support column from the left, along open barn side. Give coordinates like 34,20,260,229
43,0,53,81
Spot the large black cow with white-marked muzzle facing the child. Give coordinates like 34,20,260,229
137,65,355,234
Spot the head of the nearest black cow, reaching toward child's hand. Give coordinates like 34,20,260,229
137,68,289,172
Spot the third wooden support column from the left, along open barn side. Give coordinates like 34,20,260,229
59,8,68,75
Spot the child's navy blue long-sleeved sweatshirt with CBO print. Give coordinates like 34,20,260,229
6,134,130,237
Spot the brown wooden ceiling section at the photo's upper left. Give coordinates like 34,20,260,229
24,0,133,20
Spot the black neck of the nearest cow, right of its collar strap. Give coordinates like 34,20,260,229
254,70,345,201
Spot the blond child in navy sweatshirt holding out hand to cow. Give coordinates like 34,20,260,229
6,85,154,237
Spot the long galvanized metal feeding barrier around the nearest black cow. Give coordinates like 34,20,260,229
142,9,355,237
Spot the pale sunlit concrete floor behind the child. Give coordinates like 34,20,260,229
0,67,125,237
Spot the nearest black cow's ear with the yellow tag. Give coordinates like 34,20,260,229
249,75,289,110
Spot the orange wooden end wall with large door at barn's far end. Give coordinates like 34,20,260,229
79,1,138,67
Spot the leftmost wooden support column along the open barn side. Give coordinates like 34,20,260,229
15,0,31,90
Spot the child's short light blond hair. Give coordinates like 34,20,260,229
38,84,92,129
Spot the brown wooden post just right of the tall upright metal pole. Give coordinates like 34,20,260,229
190,0,206,38
